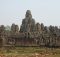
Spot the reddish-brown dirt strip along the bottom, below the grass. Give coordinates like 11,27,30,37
0,53,60,57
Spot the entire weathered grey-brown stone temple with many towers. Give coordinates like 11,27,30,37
0,10,60,47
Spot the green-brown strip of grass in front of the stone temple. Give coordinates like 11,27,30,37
0,47,60,57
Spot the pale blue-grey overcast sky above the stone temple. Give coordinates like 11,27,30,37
0,0,60,26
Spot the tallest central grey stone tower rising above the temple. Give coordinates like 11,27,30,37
20,10,35,32
